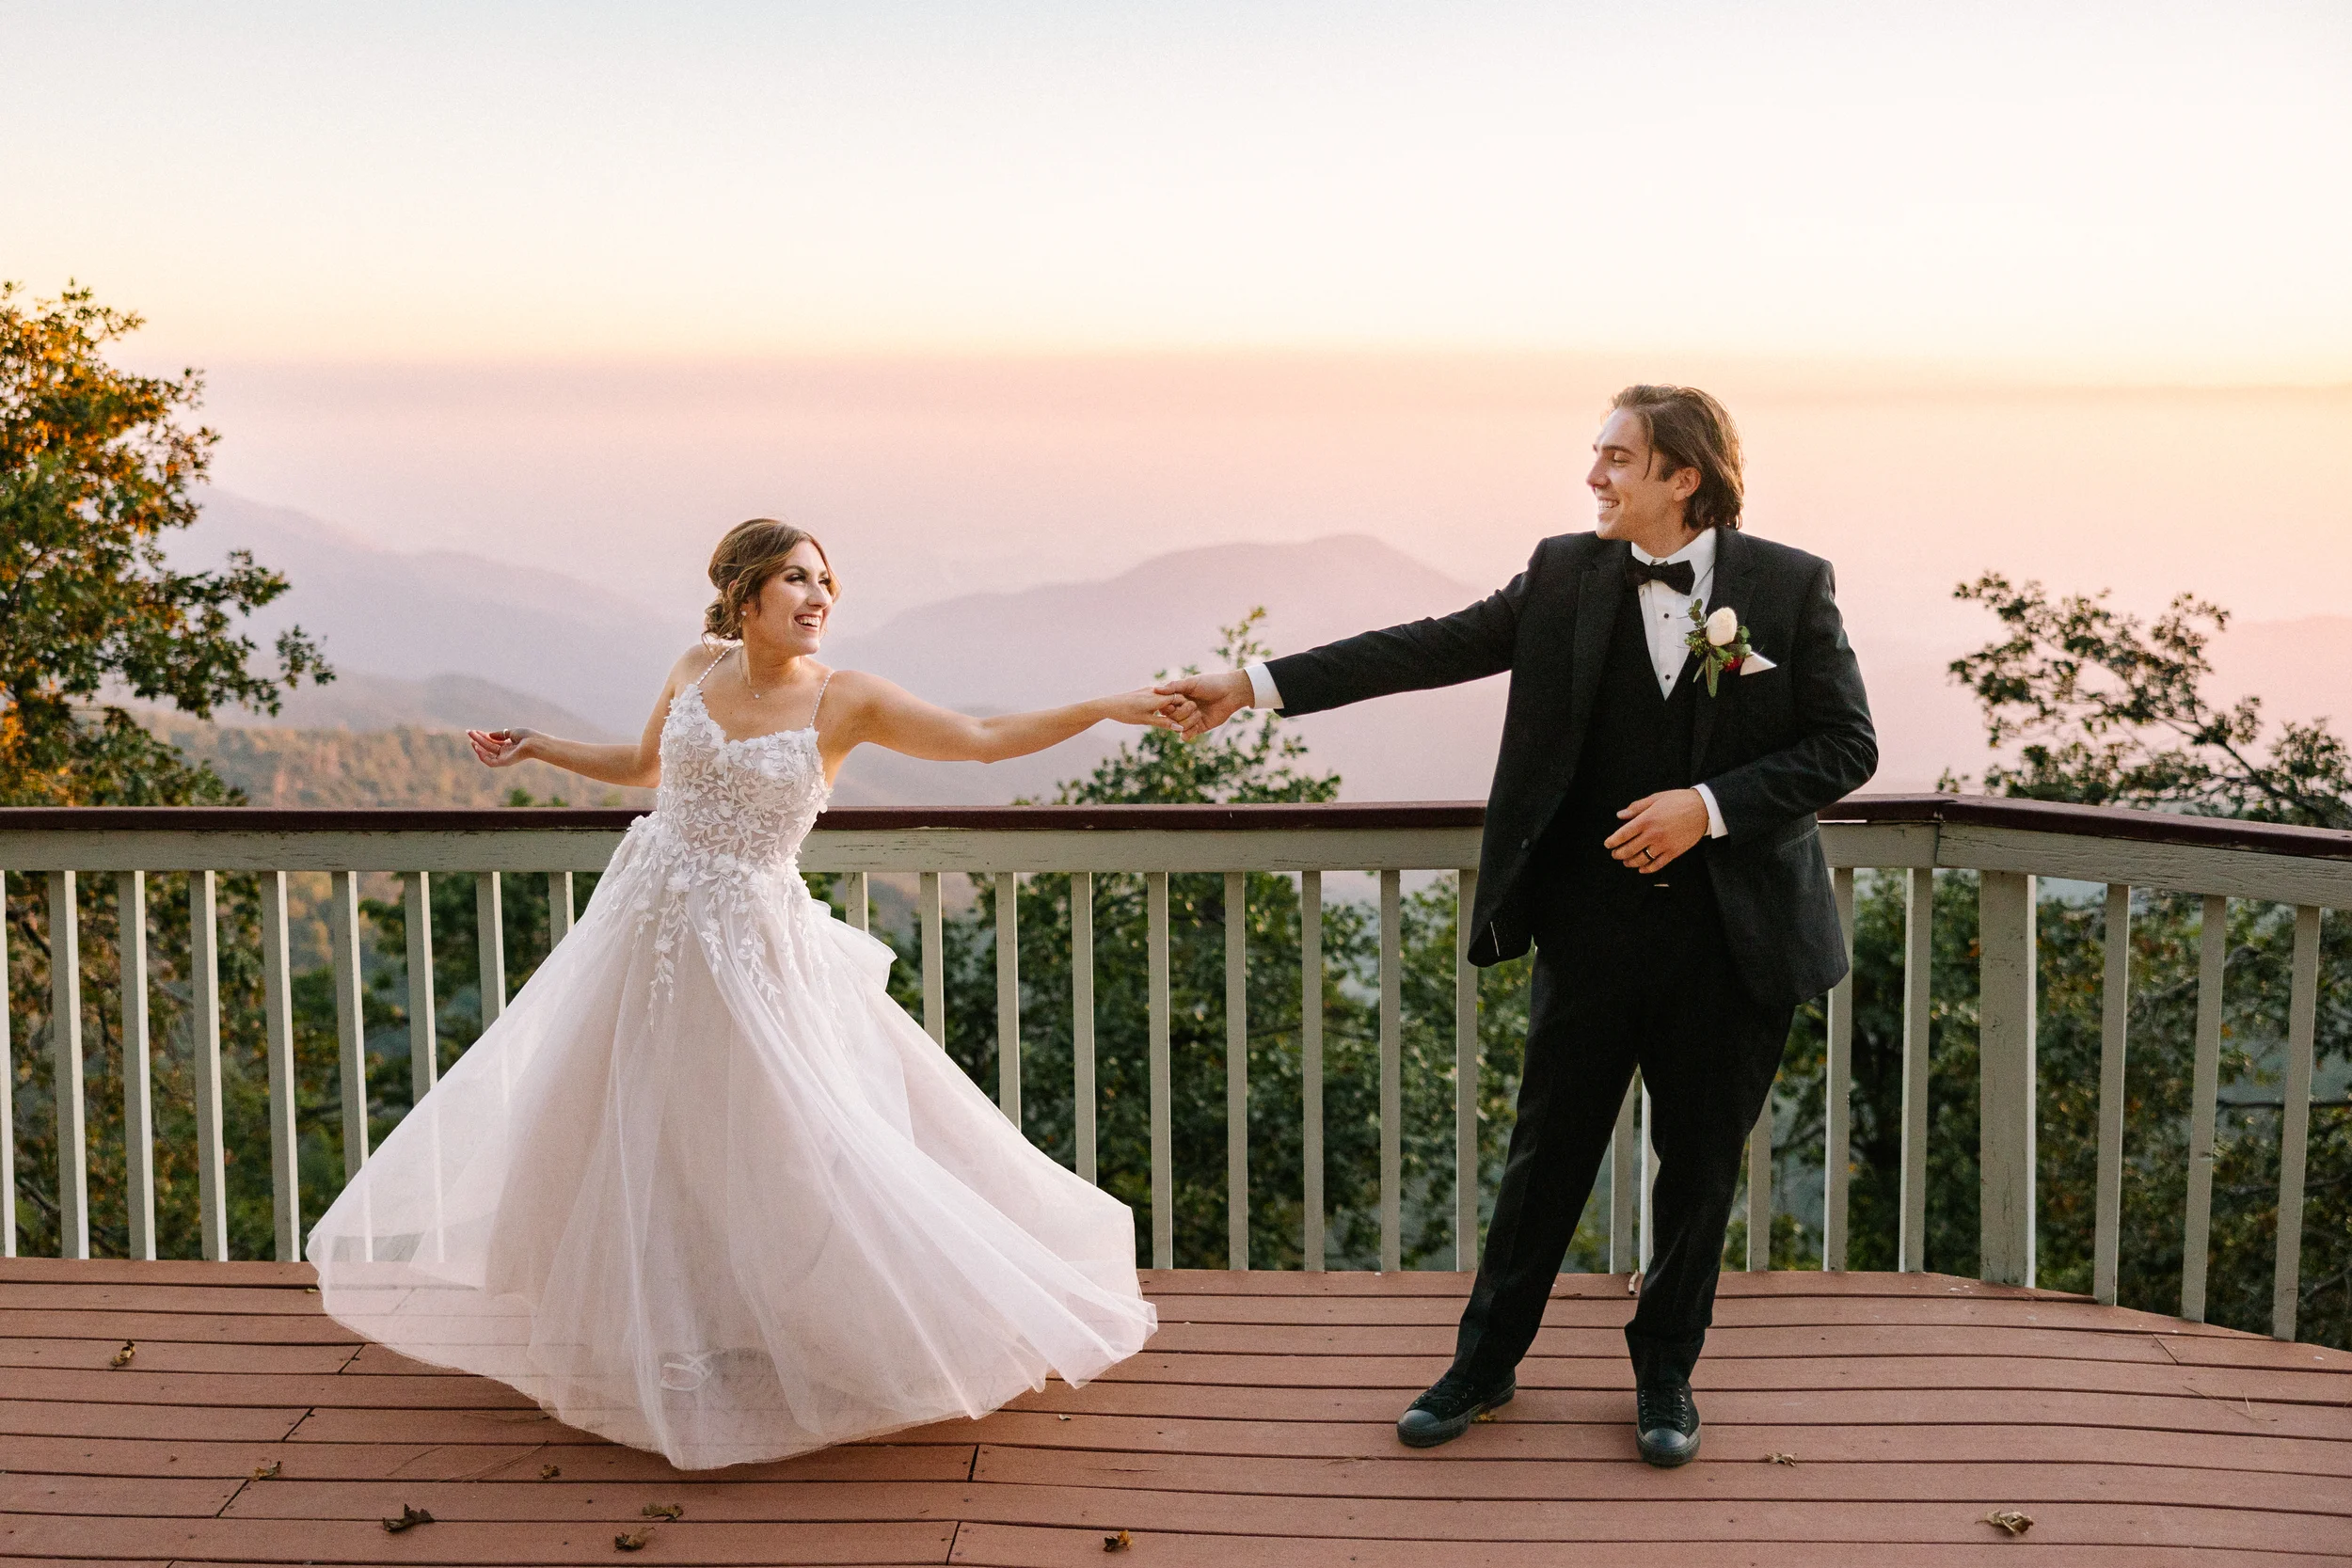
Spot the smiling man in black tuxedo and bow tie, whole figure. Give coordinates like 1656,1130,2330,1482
1162,386,1880,1465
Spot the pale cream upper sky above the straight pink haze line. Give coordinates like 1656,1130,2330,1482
0,0,2352,383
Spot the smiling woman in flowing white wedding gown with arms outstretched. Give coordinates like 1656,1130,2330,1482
309,519,1185,1469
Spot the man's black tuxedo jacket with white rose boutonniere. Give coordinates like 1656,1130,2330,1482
1268,529,1880,1004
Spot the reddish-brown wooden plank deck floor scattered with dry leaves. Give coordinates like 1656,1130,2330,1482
0,1260,2352,1568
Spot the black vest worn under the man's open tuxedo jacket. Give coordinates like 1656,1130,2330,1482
1538,576,1708,894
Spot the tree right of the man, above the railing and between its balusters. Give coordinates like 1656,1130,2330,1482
1778,574,2352,1347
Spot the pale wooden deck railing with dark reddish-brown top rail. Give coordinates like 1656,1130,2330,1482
0,795,2352,1338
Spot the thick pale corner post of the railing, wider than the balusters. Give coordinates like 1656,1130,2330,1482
1976,872,2037,1286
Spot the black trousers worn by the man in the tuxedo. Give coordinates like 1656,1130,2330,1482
1454,865,1795,1383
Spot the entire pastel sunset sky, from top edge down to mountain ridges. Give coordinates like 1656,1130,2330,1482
0,0,2352,784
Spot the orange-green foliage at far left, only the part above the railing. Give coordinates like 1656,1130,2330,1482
0,284,329,806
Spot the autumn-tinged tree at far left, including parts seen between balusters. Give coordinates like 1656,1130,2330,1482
0,284,334,1256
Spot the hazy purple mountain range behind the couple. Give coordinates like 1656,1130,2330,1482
156,491,2352,804
